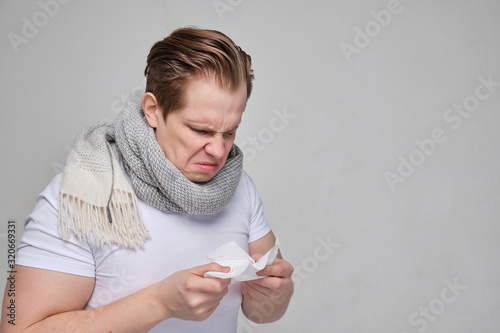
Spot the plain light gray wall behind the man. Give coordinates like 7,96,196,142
0,0,500,333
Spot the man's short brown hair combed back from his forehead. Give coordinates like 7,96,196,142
144,27,254,117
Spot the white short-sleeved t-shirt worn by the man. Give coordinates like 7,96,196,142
16,172,270,333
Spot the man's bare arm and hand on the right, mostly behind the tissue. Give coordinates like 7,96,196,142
241,232,293,323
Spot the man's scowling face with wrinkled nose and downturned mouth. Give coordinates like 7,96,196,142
155,78,247,182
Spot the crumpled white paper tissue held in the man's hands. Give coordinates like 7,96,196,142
204,239,280,283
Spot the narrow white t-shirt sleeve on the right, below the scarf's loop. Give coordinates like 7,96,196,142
242,172,271,243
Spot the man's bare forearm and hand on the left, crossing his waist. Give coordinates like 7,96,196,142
0,263,230,333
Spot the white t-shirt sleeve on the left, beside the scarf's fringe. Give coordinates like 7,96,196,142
16,175,95,277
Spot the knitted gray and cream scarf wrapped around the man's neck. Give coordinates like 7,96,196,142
58,92,243,249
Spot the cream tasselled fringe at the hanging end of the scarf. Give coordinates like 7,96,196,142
58,189,151,250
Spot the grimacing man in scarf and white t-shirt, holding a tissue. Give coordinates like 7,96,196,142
1,28,293,333
